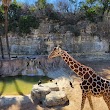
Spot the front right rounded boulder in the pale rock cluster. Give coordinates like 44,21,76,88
43,91,69,107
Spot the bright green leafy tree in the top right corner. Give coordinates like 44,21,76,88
81,0,110,21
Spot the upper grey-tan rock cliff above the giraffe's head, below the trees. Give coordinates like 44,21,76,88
0,21,110,55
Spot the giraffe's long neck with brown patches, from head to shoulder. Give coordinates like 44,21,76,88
61,50,94,78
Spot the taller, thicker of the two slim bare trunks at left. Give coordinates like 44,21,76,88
5,7,10,59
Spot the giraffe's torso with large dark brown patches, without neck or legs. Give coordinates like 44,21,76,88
81,74,110,97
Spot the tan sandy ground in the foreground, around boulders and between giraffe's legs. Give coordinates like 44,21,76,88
0,77,108,110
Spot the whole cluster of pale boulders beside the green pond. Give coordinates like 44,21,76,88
31,83,68,107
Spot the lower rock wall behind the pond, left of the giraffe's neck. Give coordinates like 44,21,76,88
0,56,70,78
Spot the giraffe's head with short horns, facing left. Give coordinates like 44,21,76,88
48,46,61,58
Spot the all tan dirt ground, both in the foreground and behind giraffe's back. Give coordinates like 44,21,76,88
1,61,110,110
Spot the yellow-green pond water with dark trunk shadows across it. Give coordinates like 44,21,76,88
0,76,49,95
